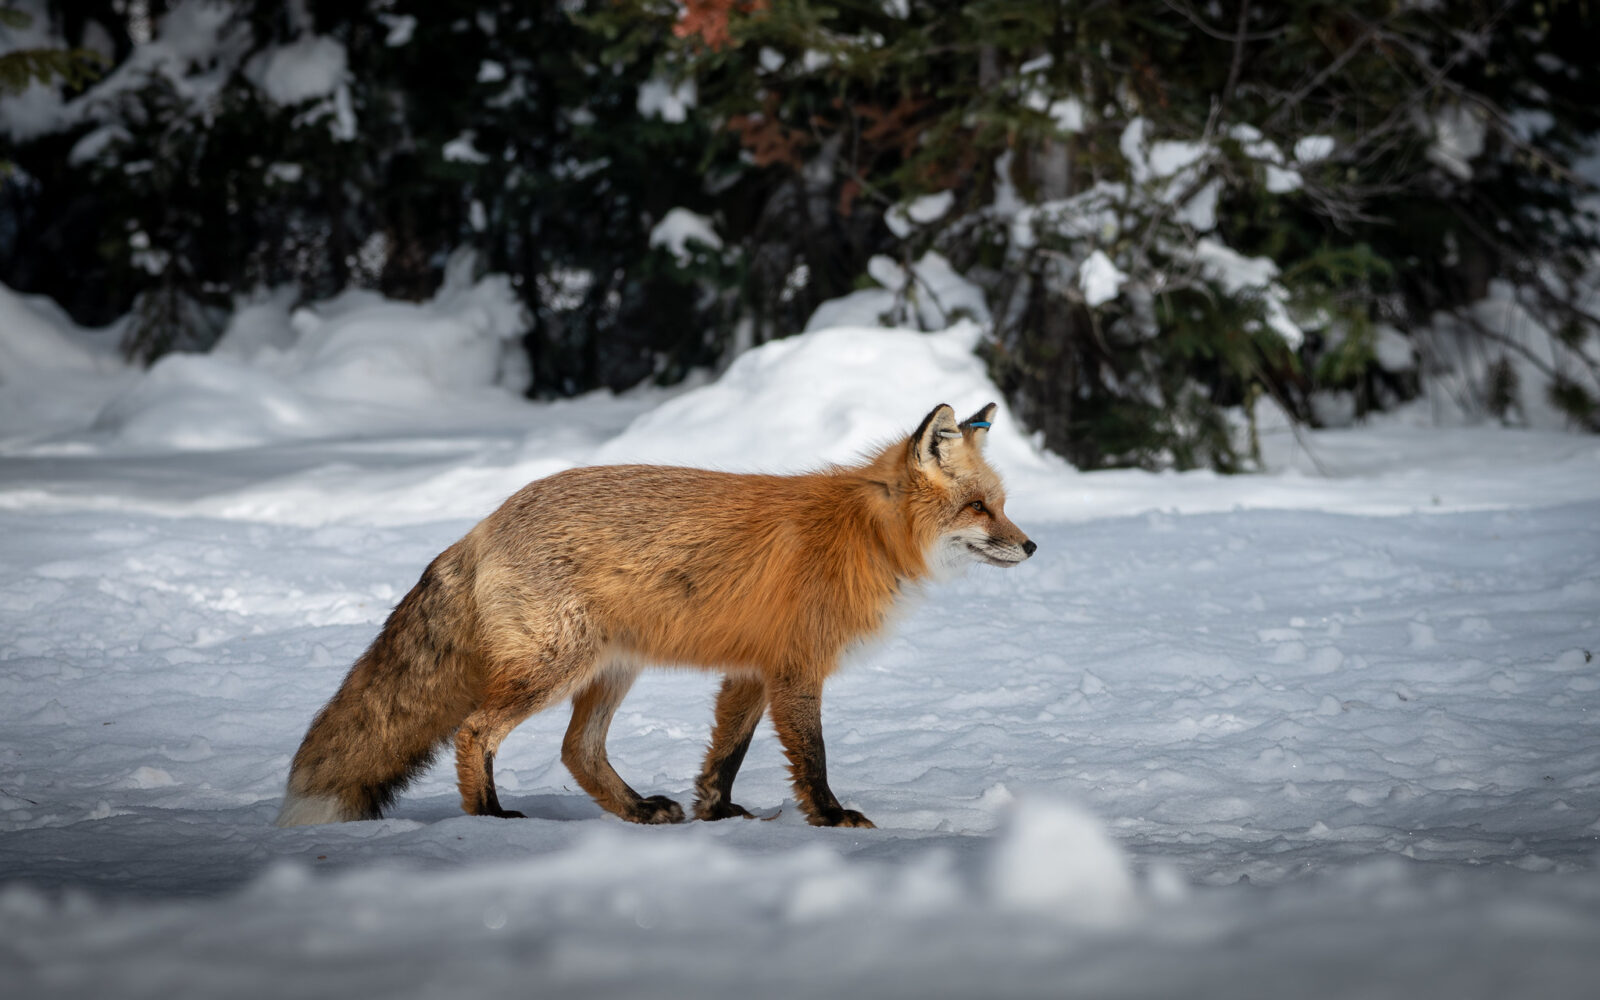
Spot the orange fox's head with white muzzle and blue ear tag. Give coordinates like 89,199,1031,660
906,403,1038,573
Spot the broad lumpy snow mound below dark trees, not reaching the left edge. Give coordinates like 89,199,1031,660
94,267,528,451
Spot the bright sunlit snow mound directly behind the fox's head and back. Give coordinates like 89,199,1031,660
594,323,1043,472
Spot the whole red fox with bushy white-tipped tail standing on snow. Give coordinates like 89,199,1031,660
278,403,1035,827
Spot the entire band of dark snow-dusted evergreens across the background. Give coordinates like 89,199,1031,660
0,0,1600,470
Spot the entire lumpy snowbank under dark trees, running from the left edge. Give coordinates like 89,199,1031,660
0,259,528,453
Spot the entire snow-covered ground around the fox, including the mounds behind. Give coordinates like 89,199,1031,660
0,285,1600,998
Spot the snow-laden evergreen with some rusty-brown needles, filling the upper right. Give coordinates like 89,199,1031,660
601,0,1600,469
